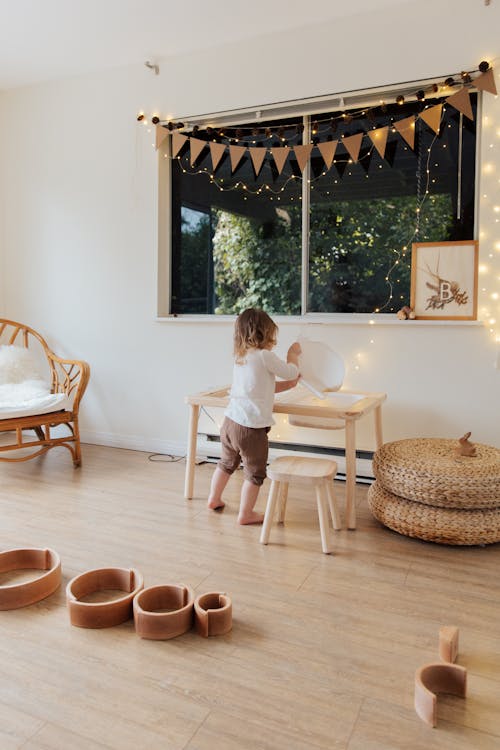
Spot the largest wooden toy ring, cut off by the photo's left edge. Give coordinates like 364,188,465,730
0,548,61,610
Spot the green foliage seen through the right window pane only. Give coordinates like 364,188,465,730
309,195,451,312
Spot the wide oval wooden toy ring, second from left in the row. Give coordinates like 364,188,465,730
66,568,144,628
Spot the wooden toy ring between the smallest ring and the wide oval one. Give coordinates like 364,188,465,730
134,584,194,641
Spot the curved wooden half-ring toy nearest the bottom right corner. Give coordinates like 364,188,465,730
415,663,467,727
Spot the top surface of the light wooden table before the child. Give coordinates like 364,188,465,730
185,383,387,420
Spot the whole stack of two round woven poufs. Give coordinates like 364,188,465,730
368,438,500,545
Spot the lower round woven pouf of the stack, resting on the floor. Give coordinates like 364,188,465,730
368,480,500,546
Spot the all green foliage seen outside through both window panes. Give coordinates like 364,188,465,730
178,194,451,315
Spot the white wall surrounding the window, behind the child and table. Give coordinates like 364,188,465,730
0,1,500,458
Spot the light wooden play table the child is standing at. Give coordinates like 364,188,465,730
184,386,386,529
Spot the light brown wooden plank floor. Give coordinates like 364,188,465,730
0,445,500,750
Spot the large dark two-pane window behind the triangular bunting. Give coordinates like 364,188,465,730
163,95,477,315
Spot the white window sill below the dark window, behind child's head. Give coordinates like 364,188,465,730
156,313,484,328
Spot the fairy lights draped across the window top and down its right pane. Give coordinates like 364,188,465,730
137,62,491,313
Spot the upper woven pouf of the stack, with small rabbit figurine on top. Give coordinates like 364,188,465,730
373,438,500,509
